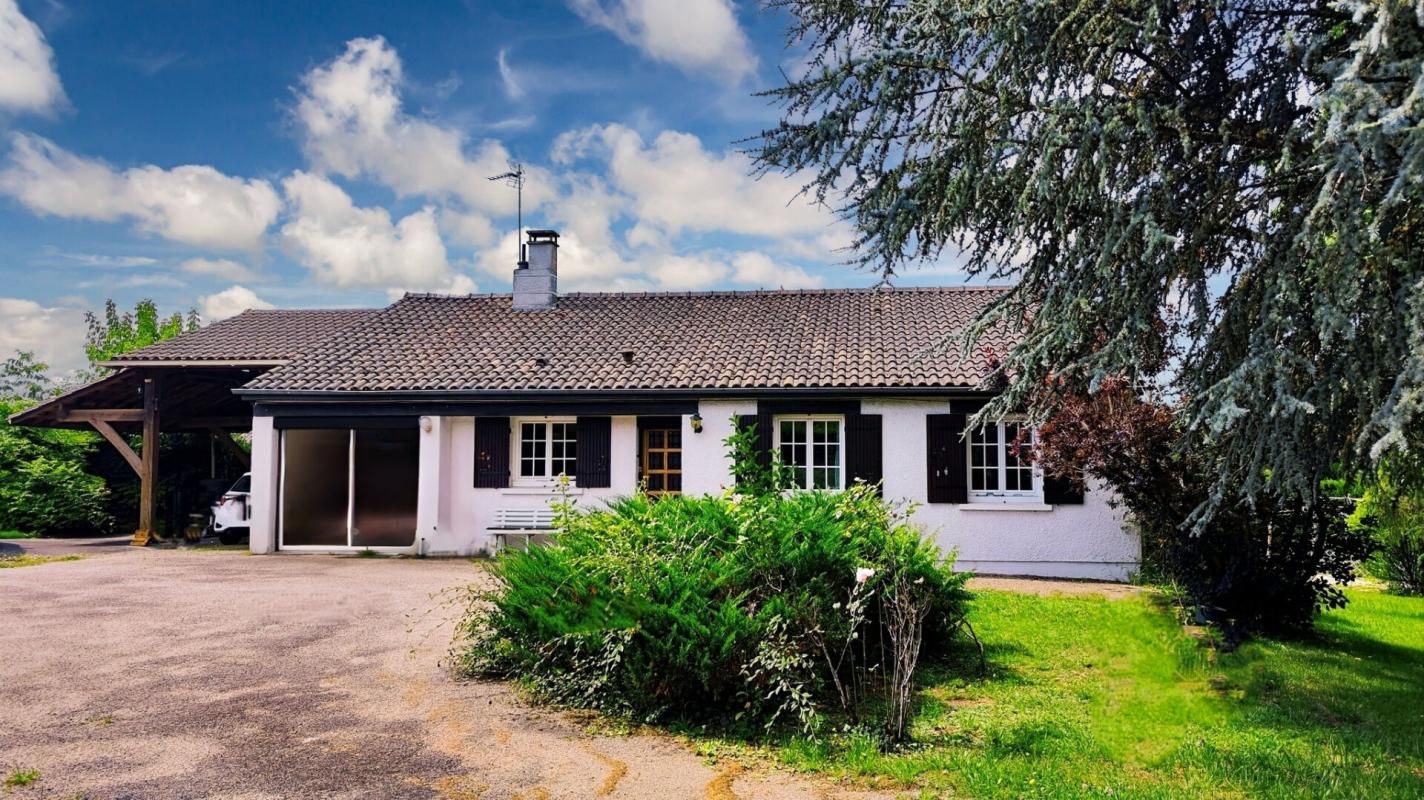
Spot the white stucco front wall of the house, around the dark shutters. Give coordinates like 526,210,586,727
252,400,1139,579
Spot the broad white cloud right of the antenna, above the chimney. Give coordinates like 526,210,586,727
554,125,836,241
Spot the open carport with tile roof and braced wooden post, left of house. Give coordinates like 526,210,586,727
10,309,372,545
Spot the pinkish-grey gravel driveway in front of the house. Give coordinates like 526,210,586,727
0,548,888,800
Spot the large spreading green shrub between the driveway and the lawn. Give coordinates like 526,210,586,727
456,435,968,733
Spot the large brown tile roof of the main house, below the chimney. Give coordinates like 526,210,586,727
246,288,1015,393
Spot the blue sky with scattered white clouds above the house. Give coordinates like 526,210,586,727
0,0,954,370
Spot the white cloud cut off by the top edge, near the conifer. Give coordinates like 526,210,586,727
568,0,756,83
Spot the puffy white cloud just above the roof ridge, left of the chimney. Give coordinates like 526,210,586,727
282,172,473,292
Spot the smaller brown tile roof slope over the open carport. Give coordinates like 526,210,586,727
112,309,380,364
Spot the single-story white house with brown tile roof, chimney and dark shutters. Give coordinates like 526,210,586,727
16,231,1139,579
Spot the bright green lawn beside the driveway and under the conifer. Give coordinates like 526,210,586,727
746,589,1424,799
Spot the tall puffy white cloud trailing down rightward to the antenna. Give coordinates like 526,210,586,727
293,37,553,214
